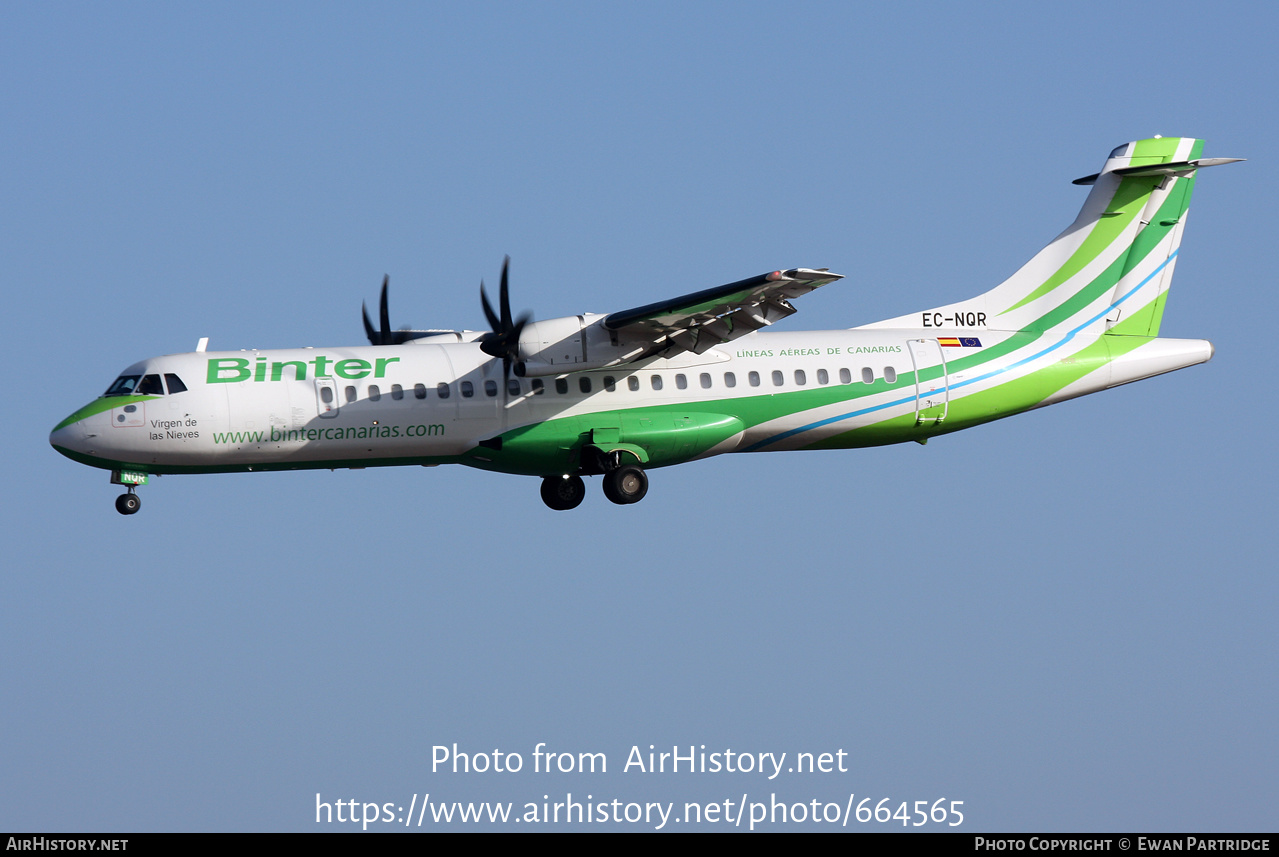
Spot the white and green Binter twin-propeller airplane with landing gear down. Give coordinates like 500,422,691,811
50,137,1242,515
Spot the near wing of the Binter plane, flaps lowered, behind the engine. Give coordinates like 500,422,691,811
604,267,843,354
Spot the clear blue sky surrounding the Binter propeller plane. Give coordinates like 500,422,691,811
0,3,1279,831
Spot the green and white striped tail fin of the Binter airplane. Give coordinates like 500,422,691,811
867,137,1239,336
